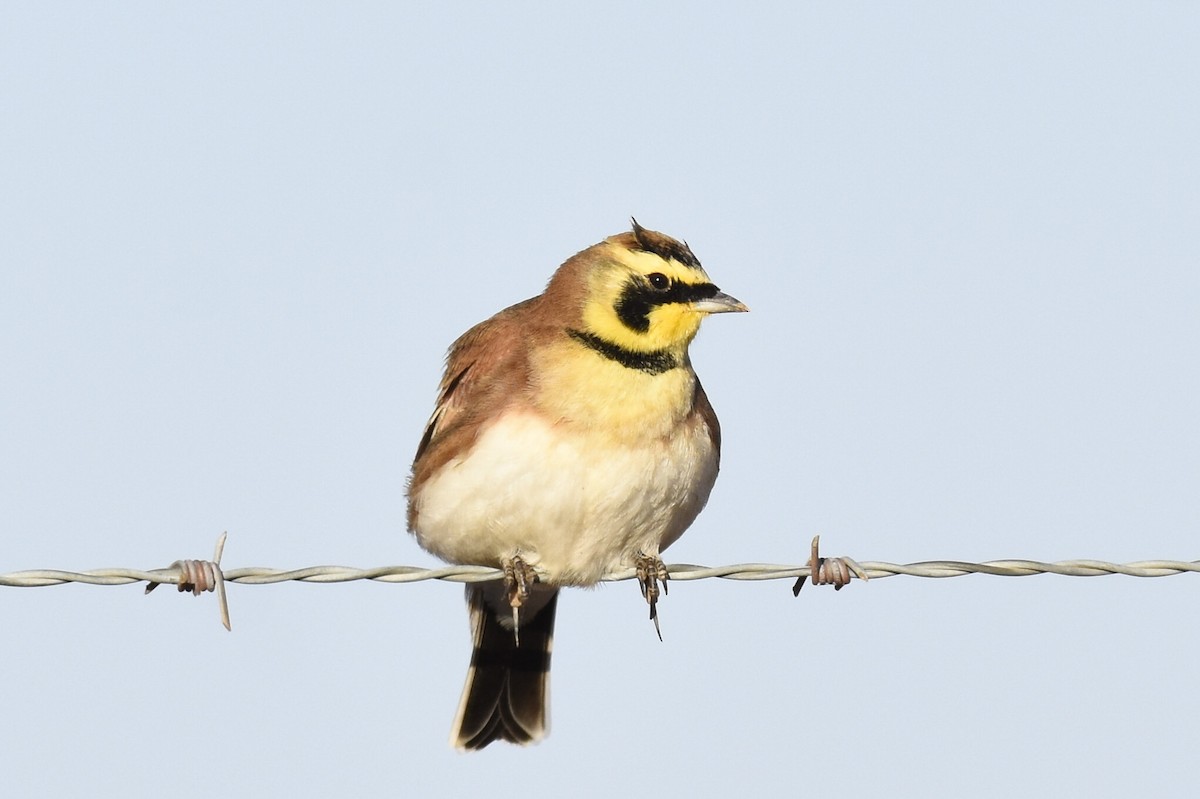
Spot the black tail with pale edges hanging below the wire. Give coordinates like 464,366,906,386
450,584,558,750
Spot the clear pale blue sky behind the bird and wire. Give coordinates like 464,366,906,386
0,2,1200,797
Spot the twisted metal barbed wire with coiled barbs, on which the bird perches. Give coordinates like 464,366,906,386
0,533,1200,630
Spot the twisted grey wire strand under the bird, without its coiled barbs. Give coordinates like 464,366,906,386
0,560,1200,588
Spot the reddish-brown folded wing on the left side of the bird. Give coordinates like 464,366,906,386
408,298,536,528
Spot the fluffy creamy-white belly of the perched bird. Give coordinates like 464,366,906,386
414,414,718,585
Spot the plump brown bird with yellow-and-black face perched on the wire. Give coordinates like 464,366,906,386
407,218,749,750
